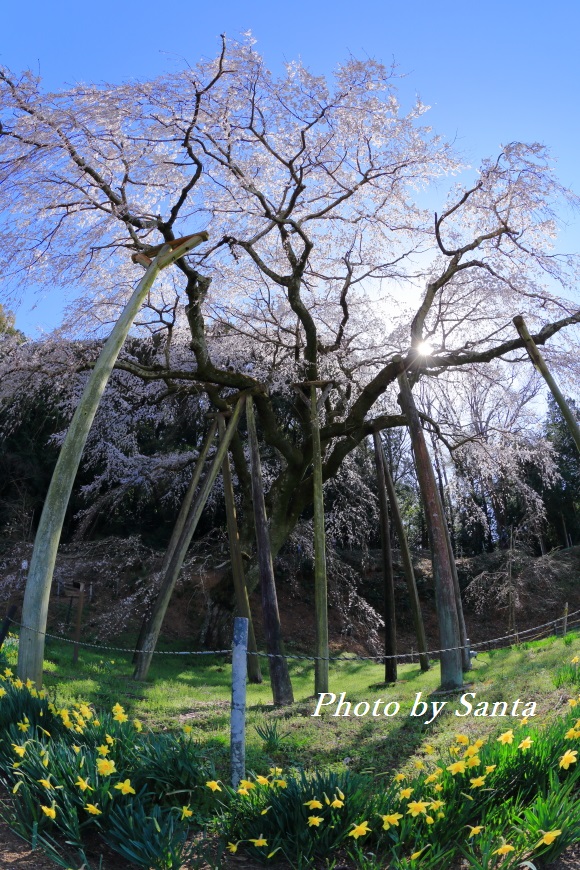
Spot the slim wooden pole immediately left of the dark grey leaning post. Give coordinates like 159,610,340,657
217,414,262,683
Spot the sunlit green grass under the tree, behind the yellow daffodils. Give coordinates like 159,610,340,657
2,636,580,776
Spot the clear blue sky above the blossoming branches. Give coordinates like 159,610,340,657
0,0,580,334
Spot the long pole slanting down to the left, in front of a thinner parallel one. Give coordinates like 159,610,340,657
134,394,245,680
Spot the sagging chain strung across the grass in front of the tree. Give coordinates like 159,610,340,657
4,610,580,664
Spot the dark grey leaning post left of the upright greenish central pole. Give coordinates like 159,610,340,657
246,396,294,706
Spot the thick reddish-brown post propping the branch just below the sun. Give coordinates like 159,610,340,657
394,357,463,690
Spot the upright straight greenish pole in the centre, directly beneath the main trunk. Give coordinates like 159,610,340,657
310,384,329,695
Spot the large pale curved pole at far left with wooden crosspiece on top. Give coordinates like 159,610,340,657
18,232,209,689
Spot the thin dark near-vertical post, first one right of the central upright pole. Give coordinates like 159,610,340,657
373,432,397,683
